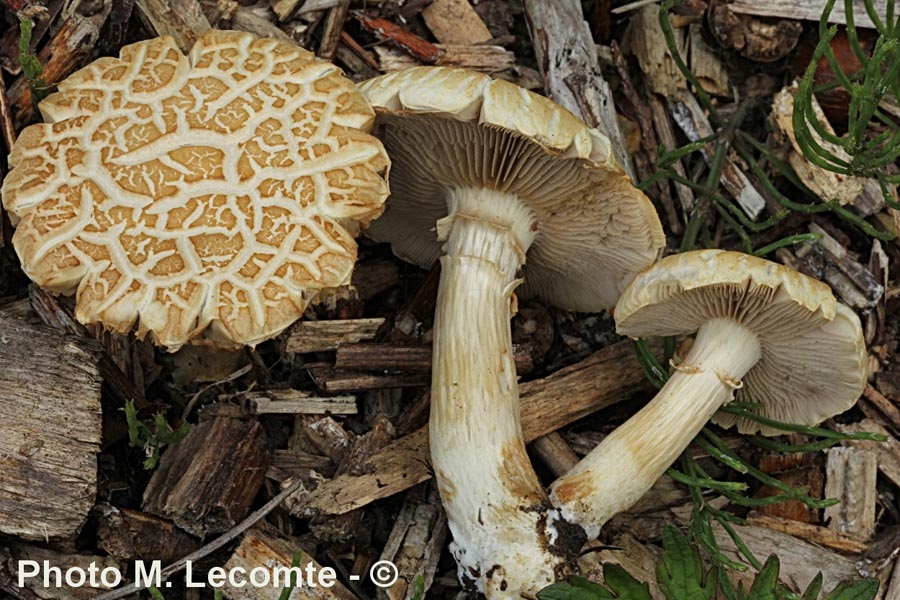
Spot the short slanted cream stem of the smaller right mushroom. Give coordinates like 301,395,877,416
550,318,761,538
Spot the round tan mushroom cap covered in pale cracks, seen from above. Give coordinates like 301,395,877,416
2,30,388,350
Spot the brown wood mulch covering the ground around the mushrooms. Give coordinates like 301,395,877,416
0,0,900,600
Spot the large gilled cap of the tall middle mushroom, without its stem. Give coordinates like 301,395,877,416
360,67,665,311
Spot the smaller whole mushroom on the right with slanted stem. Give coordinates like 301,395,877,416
551,250,867,536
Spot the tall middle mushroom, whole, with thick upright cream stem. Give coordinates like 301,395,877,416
361,67,664,598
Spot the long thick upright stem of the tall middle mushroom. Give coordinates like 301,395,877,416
430,188,584,598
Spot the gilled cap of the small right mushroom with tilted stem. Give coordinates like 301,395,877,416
615,250,868,435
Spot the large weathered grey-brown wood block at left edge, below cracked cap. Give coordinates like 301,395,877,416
0,311,101,541
